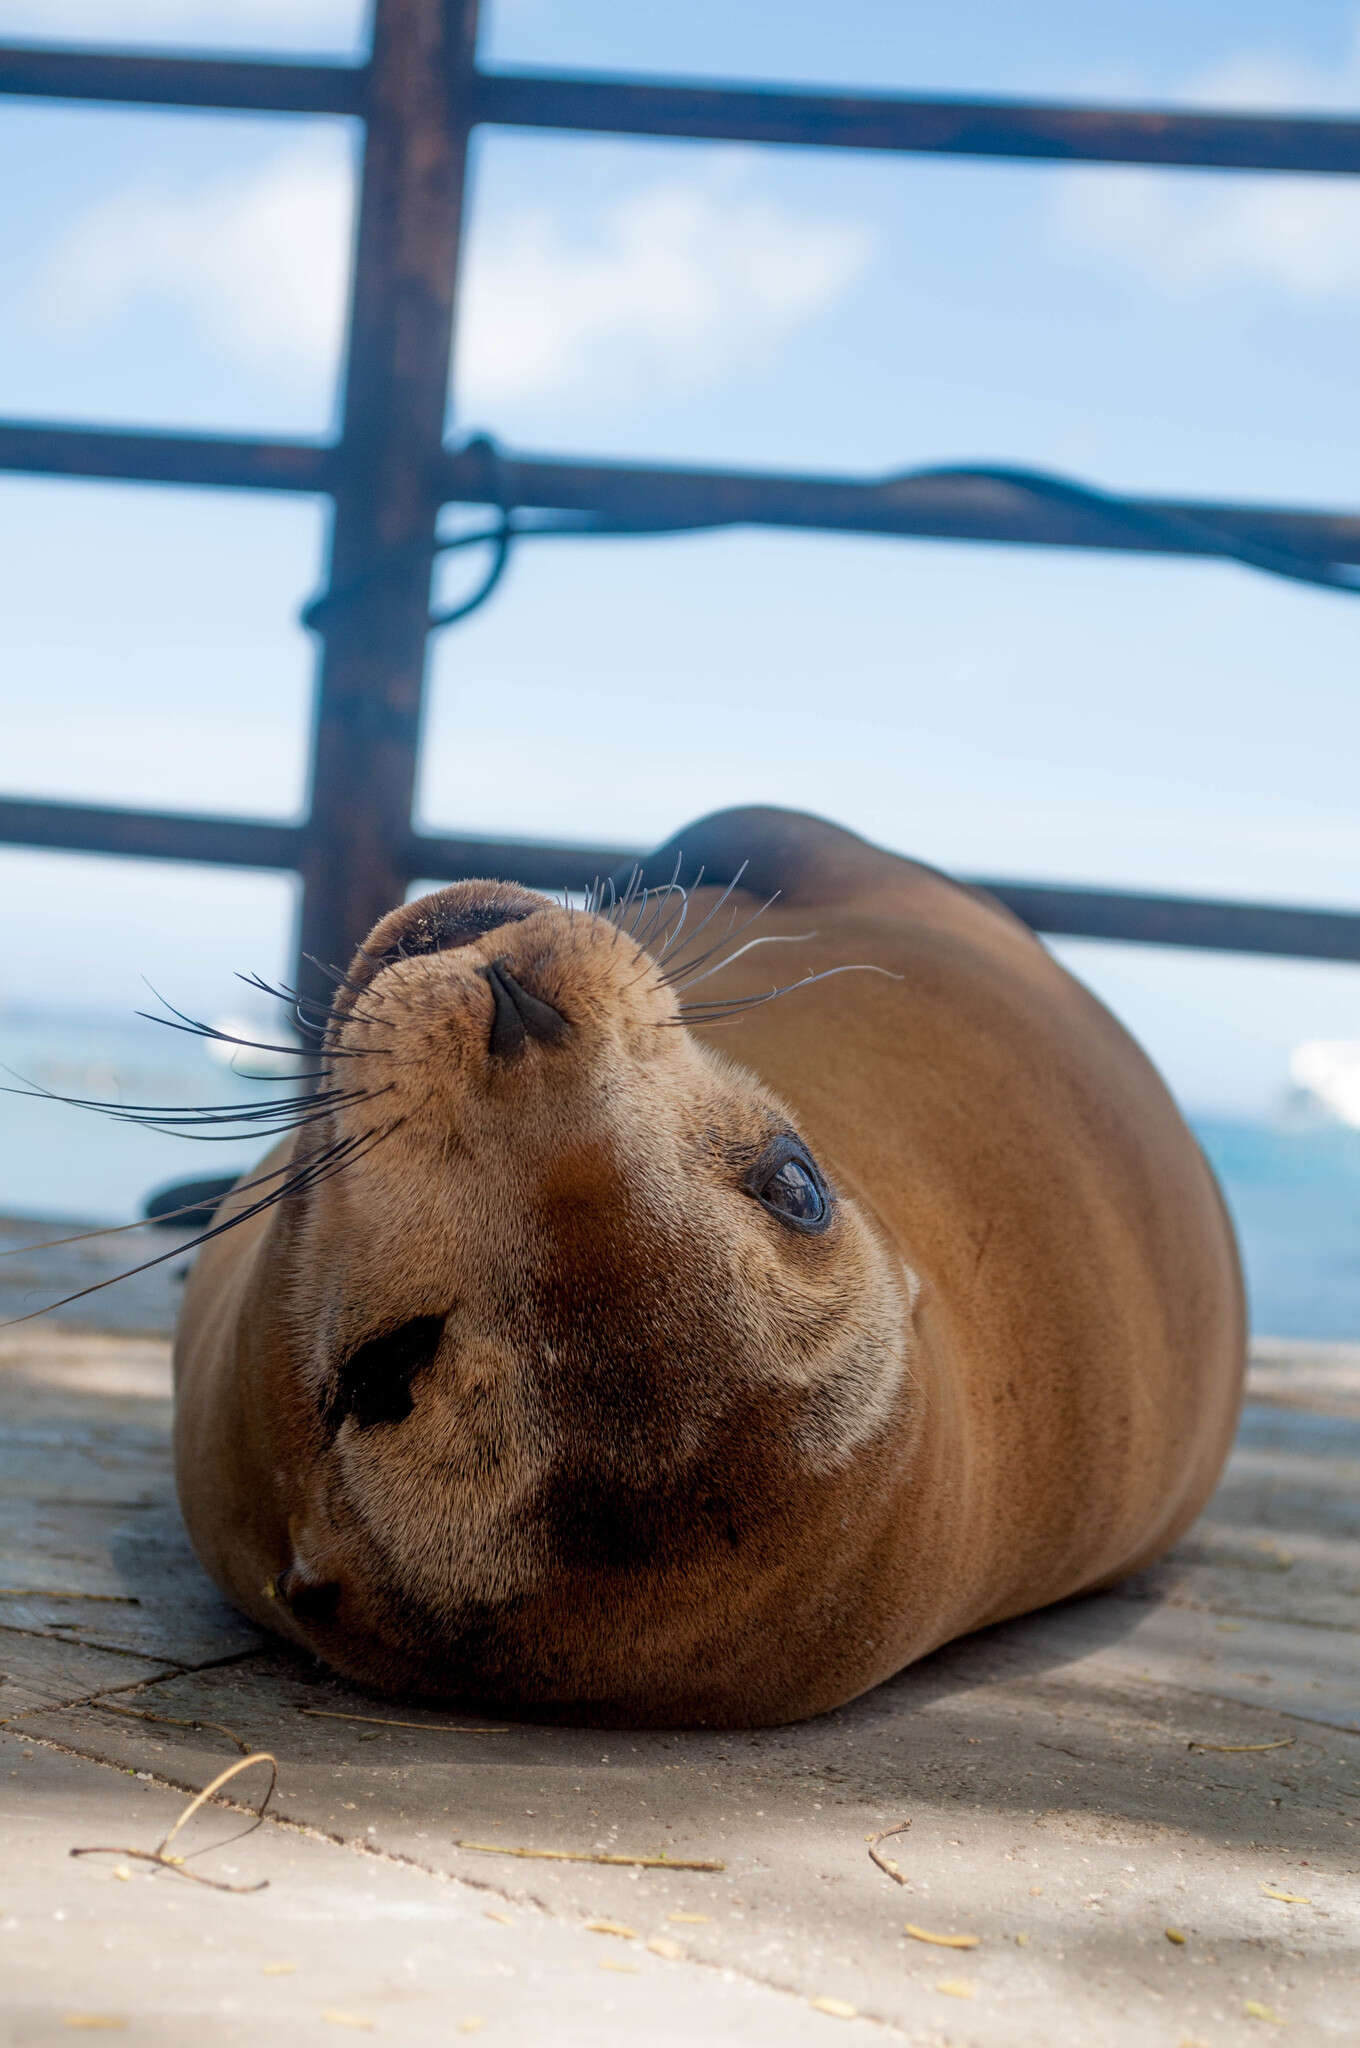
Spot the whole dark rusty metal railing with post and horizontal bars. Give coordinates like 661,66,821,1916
0,0,1360,1007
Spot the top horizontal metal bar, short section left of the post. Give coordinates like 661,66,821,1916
0,43,367,115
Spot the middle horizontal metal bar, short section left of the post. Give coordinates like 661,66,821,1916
0,420,336,492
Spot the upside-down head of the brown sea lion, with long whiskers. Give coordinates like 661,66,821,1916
248,883,909,1720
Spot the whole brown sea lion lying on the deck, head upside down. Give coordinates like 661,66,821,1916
174,809,1245,1724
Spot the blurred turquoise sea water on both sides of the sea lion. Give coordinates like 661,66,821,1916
0,1012,1360,1339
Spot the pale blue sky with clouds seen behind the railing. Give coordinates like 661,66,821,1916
0,0,1360,1108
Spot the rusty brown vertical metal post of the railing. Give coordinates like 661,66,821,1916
297,0,477,997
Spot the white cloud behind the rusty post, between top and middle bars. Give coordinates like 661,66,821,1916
35,135,873,412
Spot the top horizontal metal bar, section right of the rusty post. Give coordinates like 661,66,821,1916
475,72,1360,174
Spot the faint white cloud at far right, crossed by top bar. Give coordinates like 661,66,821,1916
1051,16,1360,301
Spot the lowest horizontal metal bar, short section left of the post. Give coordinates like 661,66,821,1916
0,797,303,868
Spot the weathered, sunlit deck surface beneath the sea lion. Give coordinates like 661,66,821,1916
0,1225,1360,2048
